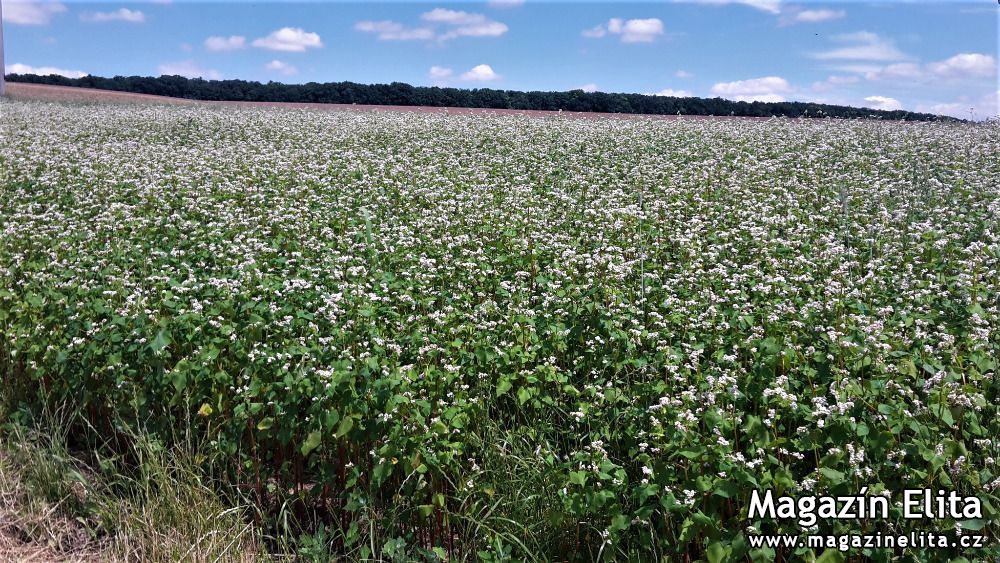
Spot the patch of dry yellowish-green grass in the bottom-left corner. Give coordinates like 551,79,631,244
0,424,273,562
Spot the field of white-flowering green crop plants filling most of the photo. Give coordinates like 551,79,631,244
0,101,1000,563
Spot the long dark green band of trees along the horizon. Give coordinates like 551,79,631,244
7,74,952,121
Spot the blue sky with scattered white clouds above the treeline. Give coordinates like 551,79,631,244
2,0,1000,118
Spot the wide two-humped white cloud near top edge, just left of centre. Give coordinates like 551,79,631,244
354,8,508,41
